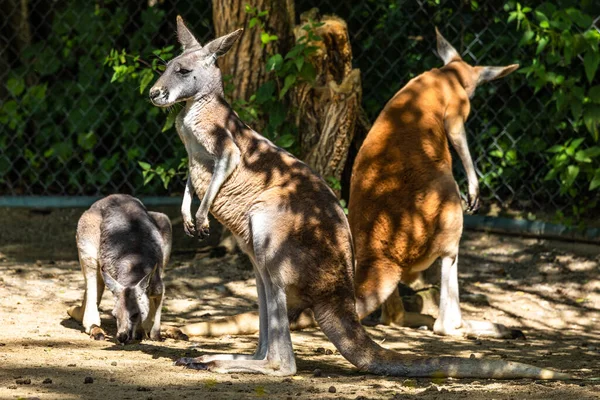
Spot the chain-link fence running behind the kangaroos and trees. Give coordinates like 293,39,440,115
0,0,600,220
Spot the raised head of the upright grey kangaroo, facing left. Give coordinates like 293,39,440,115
150,16,243,107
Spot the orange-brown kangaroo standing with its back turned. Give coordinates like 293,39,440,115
348,29,522,337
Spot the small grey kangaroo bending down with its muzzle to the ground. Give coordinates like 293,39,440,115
67,194,171,344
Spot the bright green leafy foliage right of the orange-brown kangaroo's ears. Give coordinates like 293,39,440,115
505,1,600,216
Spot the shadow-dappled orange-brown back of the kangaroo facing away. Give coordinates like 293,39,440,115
348,69,466,284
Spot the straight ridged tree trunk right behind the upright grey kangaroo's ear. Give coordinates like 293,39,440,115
213,0,295,100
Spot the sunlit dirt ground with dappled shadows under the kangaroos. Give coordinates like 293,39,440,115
0,209,600,400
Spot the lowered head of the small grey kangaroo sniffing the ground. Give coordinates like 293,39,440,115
101,264,158,344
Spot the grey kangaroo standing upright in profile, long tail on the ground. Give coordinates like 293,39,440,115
150,17,567,379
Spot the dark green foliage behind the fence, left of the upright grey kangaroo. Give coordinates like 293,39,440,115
0,0,195,194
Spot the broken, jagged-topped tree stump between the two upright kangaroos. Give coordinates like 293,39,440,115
291,9,363,196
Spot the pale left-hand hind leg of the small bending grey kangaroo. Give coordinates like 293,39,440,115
67,206,106,340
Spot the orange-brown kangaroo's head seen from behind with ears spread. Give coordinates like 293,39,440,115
435,28,519,97
